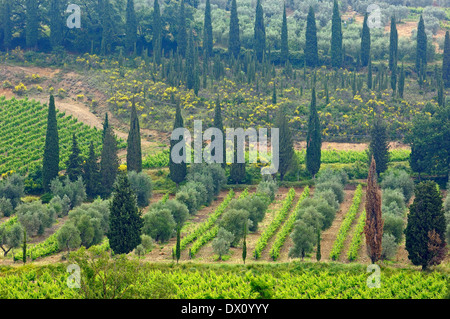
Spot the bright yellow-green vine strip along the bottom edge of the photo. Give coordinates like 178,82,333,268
0,264,448,299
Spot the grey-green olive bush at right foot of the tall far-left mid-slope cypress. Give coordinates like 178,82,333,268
50,176,86,208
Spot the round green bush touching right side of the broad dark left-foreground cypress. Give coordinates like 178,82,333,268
142,209,177,243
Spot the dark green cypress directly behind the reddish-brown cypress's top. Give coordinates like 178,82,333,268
369,117,389,174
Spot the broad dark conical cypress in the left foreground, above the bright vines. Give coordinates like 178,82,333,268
107,172,144,254
